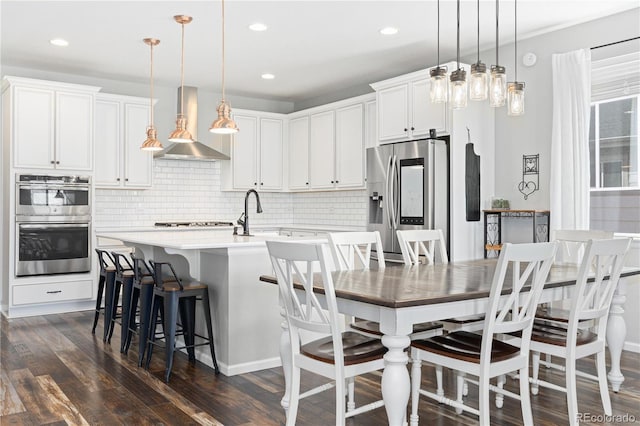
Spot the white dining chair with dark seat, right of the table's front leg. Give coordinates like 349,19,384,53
410,242,556,426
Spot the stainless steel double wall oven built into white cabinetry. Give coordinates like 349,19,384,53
15,174,91,276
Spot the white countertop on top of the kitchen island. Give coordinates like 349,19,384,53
96,228,326,250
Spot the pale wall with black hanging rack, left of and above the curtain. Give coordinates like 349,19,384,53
481,8,640,211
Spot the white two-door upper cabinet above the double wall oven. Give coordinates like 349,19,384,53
3,77,99,171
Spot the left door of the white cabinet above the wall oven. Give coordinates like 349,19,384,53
13,86,55,169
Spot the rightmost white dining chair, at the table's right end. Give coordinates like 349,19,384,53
520,238,631,425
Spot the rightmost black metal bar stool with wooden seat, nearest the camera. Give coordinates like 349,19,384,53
146,260,220,382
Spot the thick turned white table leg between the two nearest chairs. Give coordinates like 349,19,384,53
381,335,411,426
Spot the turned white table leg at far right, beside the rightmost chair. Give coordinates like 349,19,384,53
607,278,627,392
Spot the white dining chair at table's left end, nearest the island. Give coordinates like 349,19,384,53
266,241,386,426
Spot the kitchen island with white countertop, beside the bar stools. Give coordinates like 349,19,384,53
96,229,326,376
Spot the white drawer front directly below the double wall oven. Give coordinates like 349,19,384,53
12,280,93,305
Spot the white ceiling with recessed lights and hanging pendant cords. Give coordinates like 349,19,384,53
0,0,639,101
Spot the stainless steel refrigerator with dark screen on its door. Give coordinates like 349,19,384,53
367,136,450,261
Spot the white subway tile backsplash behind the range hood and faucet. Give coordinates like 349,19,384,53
94,159,366,229
